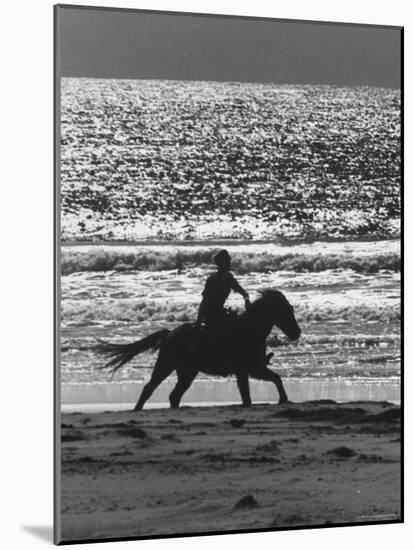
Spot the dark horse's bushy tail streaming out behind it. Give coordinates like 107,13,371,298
94,329,170,376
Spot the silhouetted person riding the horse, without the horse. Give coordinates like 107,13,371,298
196,250,250,328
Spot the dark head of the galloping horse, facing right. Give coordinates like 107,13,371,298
258,289,301,340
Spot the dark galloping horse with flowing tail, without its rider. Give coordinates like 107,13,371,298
96,289,301,411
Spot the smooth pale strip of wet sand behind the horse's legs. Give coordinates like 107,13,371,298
61,376,401,412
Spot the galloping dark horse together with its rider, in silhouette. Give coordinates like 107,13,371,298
97,250,301,410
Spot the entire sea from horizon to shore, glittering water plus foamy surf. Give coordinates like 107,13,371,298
61,78,401,408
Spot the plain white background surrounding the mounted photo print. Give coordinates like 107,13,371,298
0,0,414,550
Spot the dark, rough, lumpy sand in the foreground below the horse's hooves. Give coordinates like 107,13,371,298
61,401,401,541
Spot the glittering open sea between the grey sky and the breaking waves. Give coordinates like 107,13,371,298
61,78,401,242
